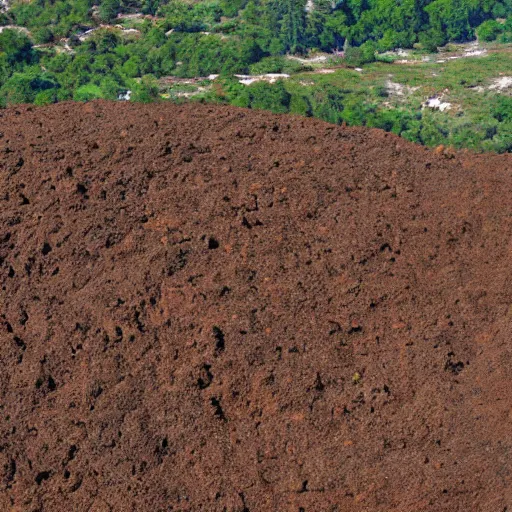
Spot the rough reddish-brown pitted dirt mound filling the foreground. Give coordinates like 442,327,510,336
0,102,512,512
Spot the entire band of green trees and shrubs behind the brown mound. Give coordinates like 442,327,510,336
0,0,512,152
